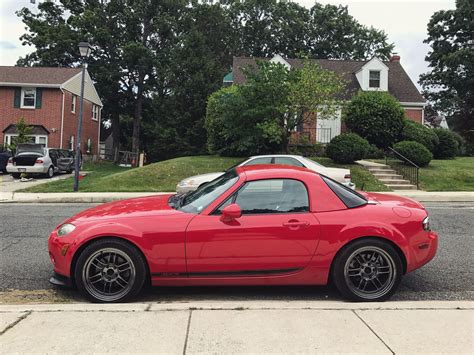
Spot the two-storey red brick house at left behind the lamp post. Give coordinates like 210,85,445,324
0,66,102,154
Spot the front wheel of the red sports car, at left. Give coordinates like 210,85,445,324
74,238,147,303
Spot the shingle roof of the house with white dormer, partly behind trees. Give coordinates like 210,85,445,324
232,57,425,103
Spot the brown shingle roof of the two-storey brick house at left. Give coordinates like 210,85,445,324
0,66,81,86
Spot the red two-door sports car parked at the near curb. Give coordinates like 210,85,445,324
49,165,438,302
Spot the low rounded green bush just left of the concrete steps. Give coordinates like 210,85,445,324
326,133,370,164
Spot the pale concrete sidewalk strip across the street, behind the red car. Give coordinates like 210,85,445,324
0,190,474,203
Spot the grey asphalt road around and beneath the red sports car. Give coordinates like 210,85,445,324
0,203,474,301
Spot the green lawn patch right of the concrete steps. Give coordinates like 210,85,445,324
419,157,474,191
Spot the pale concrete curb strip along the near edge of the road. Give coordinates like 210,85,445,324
0,300,474,313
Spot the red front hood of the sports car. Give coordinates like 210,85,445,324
67,194,183,222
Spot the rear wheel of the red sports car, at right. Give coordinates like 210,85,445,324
331,238,403,302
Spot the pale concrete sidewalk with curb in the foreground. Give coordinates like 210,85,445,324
0,300,474,354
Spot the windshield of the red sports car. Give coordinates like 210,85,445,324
178,169,239,213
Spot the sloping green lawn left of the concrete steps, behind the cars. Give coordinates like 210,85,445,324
19,156,388,192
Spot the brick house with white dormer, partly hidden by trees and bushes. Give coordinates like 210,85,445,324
223,55,426,143
